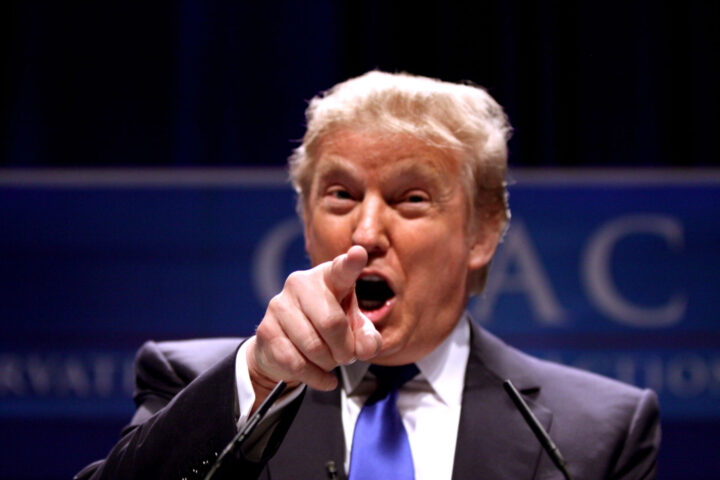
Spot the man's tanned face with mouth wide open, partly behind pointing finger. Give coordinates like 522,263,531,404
304,130,497,365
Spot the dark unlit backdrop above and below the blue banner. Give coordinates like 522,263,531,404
0,0,720,478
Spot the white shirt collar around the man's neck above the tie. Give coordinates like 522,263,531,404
340,315,470,406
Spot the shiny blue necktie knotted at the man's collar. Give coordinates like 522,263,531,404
348,364,418,480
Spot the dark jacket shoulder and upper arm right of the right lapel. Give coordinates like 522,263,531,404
474,328,660,478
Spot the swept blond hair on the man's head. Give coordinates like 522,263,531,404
289,71,512,293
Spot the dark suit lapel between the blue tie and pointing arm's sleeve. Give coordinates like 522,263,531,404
268,389,345,480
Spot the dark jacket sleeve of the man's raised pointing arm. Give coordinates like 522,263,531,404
75,342,301,480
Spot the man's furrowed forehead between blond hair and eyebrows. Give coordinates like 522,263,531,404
314,130,459,183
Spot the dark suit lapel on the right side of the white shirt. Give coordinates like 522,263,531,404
453,322,552,480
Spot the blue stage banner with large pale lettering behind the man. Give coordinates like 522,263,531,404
0,169,720,478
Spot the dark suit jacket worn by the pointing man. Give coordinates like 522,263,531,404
76,324,660,480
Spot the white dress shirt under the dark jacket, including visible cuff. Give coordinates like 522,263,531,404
235,317,470,480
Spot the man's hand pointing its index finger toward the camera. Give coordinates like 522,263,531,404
247,246,382,407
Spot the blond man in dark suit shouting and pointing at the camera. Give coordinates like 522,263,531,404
78,72,659,480
